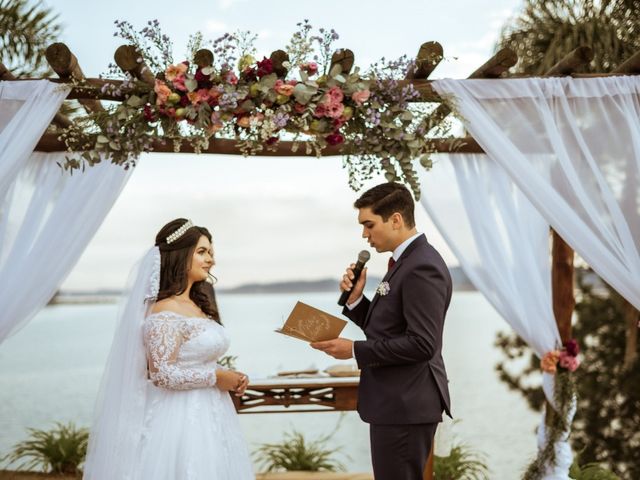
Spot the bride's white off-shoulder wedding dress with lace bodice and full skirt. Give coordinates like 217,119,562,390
137,311,255,480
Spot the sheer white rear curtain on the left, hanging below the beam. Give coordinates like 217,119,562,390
0,153,130,342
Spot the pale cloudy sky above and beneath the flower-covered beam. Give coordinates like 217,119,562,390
44,0,522,290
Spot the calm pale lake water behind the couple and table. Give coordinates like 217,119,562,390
0,292,539,480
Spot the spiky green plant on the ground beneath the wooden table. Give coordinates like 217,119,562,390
254,422,345,472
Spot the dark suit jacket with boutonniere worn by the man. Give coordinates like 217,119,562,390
343,235,452,425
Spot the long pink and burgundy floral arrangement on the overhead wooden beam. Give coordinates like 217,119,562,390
60,20,448,197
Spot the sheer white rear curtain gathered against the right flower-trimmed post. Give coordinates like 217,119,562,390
421,154,573,480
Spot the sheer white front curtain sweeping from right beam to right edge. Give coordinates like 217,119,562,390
434,76,640,309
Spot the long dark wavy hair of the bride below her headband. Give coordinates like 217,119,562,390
156,218,221,323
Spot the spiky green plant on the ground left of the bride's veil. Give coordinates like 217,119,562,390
2,422,89,474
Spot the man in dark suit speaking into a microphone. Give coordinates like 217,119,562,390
311,183,451,480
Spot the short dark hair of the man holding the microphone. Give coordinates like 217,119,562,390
353,182,416,228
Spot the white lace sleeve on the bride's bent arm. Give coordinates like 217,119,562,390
145,320,216,390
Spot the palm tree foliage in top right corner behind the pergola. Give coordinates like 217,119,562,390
498,0,640,75
